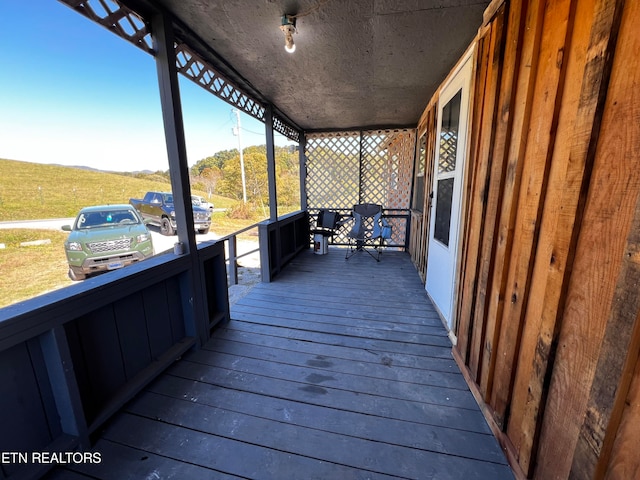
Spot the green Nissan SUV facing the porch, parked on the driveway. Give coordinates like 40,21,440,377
62,205,153,280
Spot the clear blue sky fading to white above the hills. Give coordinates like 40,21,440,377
0,0,290,171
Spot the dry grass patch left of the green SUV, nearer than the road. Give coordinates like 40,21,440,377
0,229,73,308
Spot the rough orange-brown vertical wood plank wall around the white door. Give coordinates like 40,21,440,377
412,0,640,480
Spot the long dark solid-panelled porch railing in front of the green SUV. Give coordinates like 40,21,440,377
0,242,229,478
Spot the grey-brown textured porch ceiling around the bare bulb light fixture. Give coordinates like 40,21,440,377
140,0,490,130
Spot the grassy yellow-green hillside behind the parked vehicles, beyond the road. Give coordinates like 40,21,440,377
0,159,229,221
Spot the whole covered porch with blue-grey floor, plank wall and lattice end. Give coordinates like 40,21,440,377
0,0,640,480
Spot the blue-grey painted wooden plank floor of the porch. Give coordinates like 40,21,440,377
50,250,513,480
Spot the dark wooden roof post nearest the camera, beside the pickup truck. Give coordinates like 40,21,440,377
151,12,208,343
